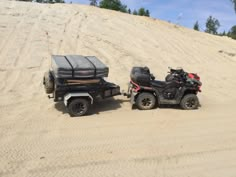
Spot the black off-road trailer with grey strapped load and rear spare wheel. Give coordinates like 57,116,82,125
43,55,120,116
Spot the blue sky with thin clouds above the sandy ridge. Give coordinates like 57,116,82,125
66,0,236,32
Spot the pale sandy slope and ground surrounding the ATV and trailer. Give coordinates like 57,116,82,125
0,0,236,177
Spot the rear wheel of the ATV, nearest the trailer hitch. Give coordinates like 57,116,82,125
136,92,156,110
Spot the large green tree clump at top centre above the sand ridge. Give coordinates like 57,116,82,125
99,0,127,12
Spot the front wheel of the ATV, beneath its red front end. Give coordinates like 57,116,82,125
180,94,199,110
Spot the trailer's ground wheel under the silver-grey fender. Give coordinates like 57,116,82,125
68,98,90,117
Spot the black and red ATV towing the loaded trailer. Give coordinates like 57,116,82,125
126,67,202,110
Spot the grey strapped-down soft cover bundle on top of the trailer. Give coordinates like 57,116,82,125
52,55,109,79
